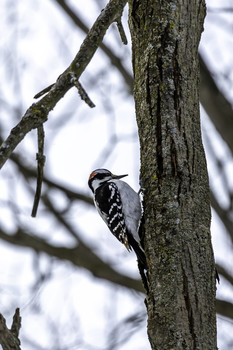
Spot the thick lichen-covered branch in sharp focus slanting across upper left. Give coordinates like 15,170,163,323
0,0,127,169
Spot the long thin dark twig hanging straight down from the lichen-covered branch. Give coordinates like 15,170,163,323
31,124,45,217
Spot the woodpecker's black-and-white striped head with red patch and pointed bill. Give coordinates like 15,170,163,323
88,169,128,192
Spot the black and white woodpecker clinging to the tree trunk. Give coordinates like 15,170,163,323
88,169,147,269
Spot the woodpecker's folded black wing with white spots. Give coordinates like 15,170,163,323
95,182,131,250
